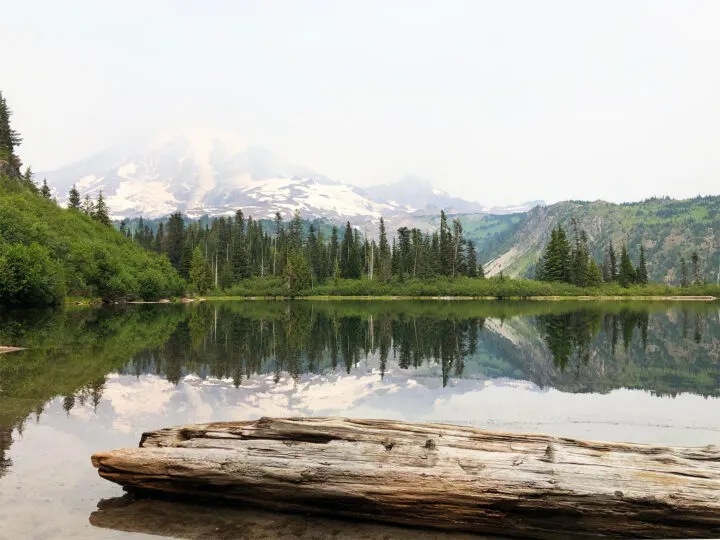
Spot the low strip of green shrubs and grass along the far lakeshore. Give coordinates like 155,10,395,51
204,278,720,300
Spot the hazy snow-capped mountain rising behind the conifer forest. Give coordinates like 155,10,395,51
39,130,540,223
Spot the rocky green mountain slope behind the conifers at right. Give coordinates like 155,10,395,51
482,196,720,283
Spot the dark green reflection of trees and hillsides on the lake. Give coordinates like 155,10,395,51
0,301,720,476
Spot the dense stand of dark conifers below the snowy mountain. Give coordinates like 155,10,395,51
115,210,483,294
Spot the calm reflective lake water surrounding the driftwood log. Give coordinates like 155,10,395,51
0,300,720,539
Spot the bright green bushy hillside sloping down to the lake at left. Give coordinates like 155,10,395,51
0,177,184,304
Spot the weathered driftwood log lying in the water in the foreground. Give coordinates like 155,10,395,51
92,418,720,538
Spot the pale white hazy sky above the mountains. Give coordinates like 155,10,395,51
0,0,720,204
